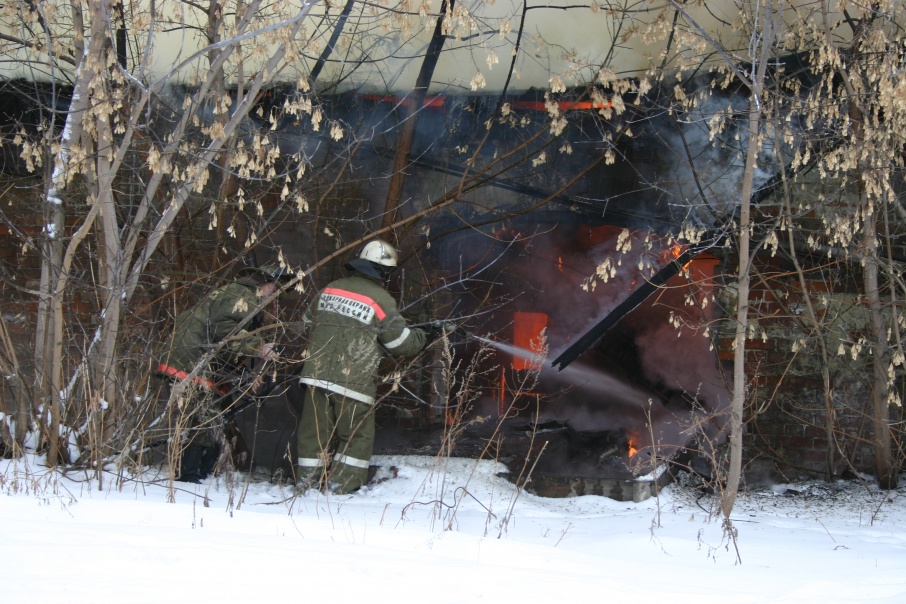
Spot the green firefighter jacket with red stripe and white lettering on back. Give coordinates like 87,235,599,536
300,274,426,404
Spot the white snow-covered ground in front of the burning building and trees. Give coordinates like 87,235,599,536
0,457,906,604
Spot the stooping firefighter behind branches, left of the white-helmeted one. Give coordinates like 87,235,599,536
156,265,291,482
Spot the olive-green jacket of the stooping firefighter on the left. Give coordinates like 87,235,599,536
158,283,264,377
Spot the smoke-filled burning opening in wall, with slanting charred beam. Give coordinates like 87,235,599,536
382,221,729,497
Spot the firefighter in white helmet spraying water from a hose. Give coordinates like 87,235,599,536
297,239,429,494
